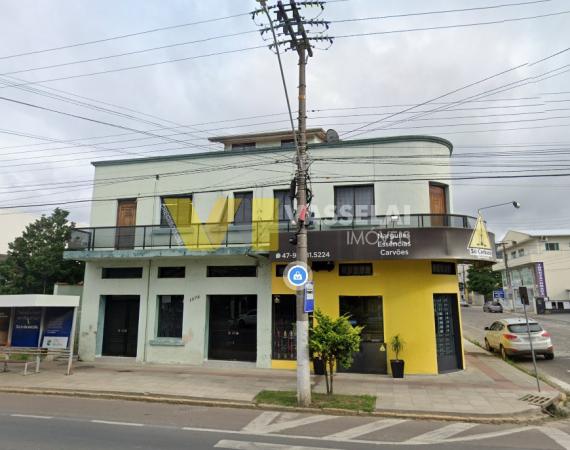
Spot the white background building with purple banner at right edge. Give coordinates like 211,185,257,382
493,230,570,310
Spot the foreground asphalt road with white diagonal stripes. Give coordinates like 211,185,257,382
0,394,570,450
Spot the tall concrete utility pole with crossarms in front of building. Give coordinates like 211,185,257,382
253,0,332,406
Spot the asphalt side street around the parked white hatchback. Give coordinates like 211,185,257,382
461,306,570,387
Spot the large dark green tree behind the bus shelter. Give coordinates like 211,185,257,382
0,208,85,294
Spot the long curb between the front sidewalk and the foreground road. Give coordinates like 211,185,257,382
0,386,549,425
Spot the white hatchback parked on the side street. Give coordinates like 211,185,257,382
485,317,554,359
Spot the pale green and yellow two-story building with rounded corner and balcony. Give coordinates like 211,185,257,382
65,129,495,374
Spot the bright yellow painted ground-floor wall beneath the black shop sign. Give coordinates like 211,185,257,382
271,260,465,375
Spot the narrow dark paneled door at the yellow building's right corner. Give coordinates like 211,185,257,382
433,294,462,373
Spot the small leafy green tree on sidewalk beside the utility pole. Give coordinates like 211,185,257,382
309,309,363,394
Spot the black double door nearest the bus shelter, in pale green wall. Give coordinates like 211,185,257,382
103,295,140,357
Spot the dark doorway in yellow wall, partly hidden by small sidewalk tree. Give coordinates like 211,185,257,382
338,296,388,374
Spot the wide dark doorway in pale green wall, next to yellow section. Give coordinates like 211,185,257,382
208,295,257,361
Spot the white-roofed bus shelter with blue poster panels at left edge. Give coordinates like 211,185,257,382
0,294,80,375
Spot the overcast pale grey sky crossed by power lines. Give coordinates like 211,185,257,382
0,0,570,237
